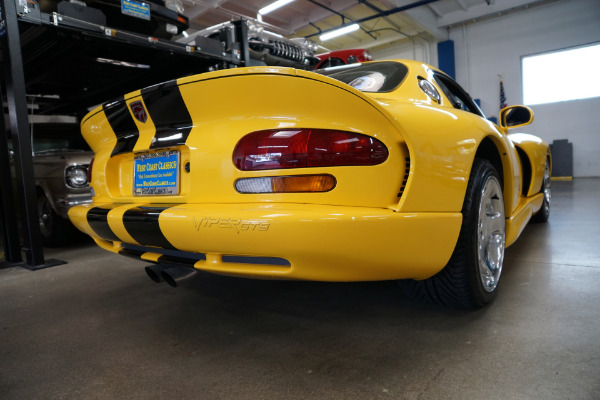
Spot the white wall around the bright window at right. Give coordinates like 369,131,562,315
449,0,600,177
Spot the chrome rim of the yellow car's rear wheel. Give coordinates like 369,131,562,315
477,176,506,293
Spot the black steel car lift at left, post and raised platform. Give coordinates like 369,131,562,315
0,0,249,269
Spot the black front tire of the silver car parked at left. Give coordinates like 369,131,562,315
37,194,76,247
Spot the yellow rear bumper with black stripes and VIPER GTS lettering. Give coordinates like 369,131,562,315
69,203,462,281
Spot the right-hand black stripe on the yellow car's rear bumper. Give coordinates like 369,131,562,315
123,207,175,249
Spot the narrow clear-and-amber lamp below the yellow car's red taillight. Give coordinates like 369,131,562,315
235,175,336,193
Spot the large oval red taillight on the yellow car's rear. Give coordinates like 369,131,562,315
233,129,388,171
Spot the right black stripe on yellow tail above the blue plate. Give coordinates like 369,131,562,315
142,81,193,149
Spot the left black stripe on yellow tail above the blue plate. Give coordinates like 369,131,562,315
102,97,140,156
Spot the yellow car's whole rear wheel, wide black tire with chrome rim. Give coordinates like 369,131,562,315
401,158,506,308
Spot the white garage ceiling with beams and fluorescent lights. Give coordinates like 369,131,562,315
182,0,548,52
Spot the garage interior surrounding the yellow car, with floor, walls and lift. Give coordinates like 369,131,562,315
0,0,600,399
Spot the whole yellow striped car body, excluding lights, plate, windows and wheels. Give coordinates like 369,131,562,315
69,61,547,281
